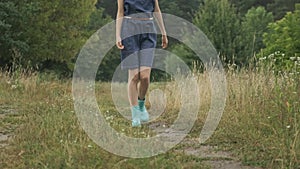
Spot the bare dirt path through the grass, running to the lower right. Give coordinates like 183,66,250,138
150,124,259,169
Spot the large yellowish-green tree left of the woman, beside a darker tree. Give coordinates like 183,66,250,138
18,0,95,69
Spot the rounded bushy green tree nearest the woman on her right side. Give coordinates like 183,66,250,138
194,0,240,61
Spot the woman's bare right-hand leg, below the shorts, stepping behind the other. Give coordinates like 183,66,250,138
138,67,151,100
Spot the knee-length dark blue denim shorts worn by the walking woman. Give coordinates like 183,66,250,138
121,18,157,69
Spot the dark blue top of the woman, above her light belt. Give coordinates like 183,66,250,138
124,0,155,17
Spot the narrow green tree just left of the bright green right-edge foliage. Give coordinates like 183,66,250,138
239,7,273,61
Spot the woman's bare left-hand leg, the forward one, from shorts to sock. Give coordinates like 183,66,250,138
128,69,139,106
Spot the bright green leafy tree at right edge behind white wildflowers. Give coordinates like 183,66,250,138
260,4,300,72
